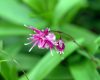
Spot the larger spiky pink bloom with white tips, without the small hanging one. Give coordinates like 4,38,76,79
25,27,56,54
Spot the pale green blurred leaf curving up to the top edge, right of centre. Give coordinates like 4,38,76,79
54,0,84,23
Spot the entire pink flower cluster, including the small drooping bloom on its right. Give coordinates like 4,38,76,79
25,26,65,56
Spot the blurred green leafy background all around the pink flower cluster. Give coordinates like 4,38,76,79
0,0,100,80
